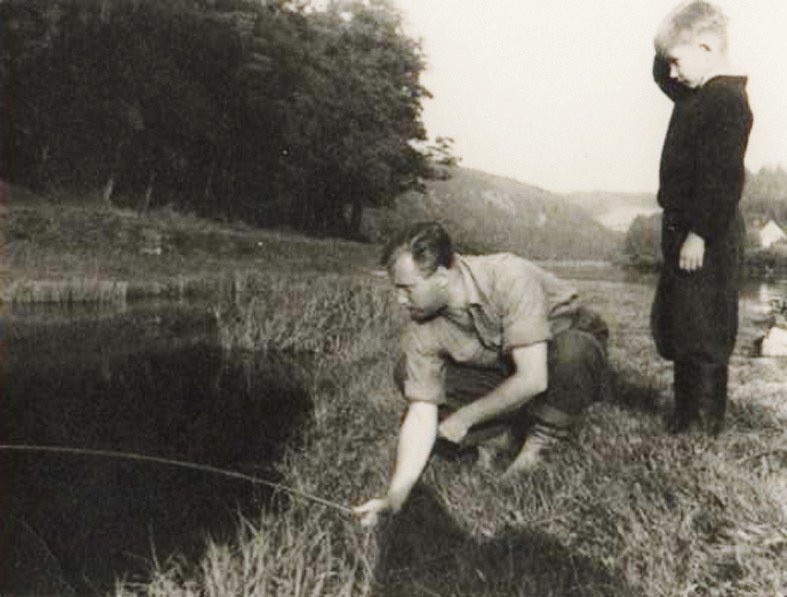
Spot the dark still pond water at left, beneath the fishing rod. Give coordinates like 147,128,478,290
0,305,310,595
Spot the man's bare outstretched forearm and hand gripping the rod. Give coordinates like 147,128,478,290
353,402,437,526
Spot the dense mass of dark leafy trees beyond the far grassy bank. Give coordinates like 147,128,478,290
0,0,446,234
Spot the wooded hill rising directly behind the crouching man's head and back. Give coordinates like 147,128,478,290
362,168,622,260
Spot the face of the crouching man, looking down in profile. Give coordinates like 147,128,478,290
390,253,448,321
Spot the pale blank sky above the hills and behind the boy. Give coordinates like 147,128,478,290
394,0,787,192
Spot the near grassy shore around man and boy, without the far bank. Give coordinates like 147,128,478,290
112,276,787,597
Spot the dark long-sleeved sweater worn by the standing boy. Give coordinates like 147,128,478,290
653,57,752,244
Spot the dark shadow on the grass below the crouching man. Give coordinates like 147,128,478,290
375,486,641,597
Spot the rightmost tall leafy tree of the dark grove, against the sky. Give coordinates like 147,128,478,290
272,1,428,234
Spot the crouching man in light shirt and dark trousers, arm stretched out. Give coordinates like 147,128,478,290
354,222,608,526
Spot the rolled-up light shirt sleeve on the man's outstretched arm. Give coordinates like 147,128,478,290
402,327,446,404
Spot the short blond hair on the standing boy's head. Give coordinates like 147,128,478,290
653,0,729,56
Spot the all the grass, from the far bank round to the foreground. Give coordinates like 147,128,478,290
3,193,787,597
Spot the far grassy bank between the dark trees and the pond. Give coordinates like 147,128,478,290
0,188,375,304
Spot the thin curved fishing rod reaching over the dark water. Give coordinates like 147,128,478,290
0,444,352,514
